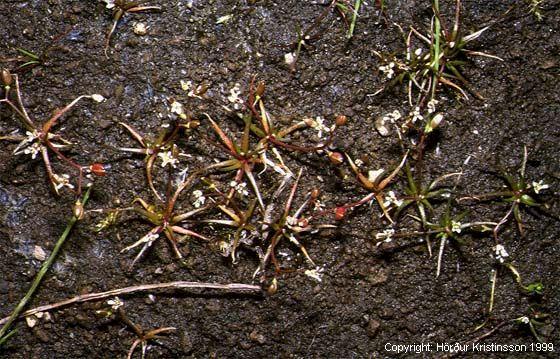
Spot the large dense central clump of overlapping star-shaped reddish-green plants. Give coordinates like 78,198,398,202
93,80,347,281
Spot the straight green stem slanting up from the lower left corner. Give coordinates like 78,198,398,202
0,187,91,346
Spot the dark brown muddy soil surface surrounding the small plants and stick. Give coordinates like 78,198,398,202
0,0,560,358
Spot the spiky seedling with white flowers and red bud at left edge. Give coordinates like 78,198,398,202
0,70,105,194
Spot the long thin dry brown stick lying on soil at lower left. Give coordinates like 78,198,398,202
0,281,262,325
